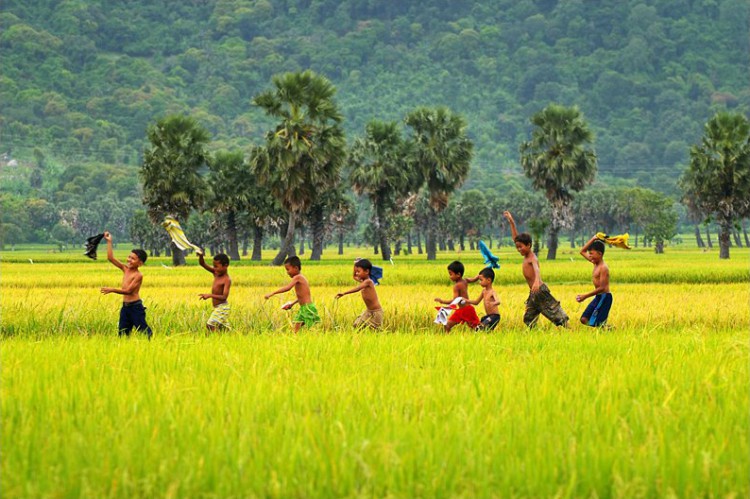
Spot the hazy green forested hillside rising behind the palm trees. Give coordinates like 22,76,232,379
0,0,750,191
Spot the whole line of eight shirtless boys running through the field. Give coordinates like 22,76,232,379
101,211,612,338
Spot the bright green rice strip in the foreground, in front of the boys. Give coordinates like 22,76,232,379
0,329,750,497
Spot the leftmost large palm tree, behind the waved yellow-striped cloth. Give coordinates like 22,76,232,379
140,115,210,266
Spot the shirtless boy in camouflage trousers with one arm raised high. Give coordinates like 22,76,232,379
503,211,568,328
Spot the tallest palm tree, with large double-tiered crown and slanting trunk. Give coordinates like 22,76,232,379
251,71,346,265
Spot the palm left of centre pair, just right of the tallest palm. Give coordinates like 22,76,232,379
349,120,414,261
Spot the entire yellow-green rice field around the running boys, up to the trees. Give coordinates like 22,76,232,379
0,247,750,498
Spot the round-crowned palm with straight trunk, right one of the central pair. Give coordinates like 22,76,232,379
405,107,473,260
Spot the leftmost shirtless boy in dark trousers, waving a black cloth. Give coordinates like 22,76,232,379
101,232,153,339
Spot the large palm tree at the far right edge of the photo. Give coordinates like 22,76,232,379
680,112,750,258
